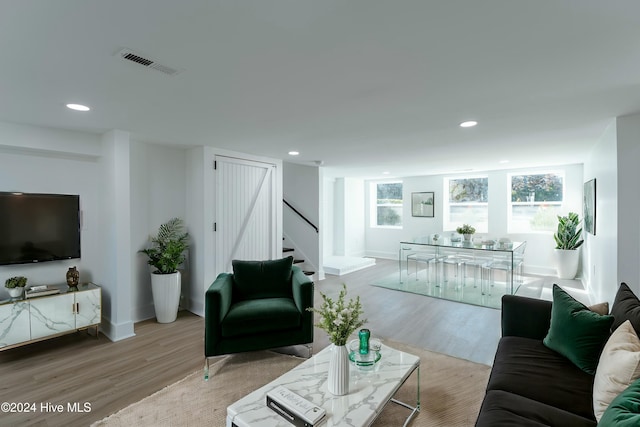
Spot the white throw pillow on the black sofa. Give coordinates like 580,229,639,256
593,320,640,421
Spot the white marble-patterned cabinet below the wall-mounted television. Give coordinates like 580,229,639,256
0,283,102,351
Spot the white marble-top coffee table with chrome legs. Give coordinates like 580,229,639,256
227,344,420,427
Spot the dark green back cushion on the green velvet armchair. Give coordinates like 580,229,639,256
232,257,293,301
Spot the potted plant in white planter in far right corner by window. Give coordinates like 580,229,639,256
553,212,584,279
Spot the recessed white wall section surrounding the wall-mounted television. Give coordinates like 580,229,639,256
0,127,104,299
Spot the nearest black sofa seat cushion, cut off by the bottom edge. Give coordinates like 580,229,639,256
476,390,596,427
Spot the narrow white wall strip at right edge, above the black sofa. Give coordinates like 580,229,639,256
609,114,640,295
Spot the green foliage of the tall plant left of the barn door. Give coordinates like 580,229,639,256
140,218,189,274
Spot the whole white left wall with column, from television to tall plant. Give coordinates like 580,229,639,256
0,122,188,340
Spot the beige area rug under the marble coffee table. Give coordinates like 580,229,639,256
92,340,490,427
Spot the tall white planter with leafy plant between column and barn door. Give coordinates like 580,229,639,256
140,218,189,323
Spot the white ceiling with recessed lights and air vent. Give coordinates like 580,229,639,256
0,0,640,177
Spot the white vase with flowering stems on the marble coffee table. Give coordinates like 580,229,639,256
308,284,367,396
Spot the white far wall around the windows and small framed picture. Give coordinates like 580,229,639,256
365,165,583,274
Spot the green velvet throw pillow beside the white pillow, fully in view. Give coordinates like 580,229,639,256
543,285,613,375
